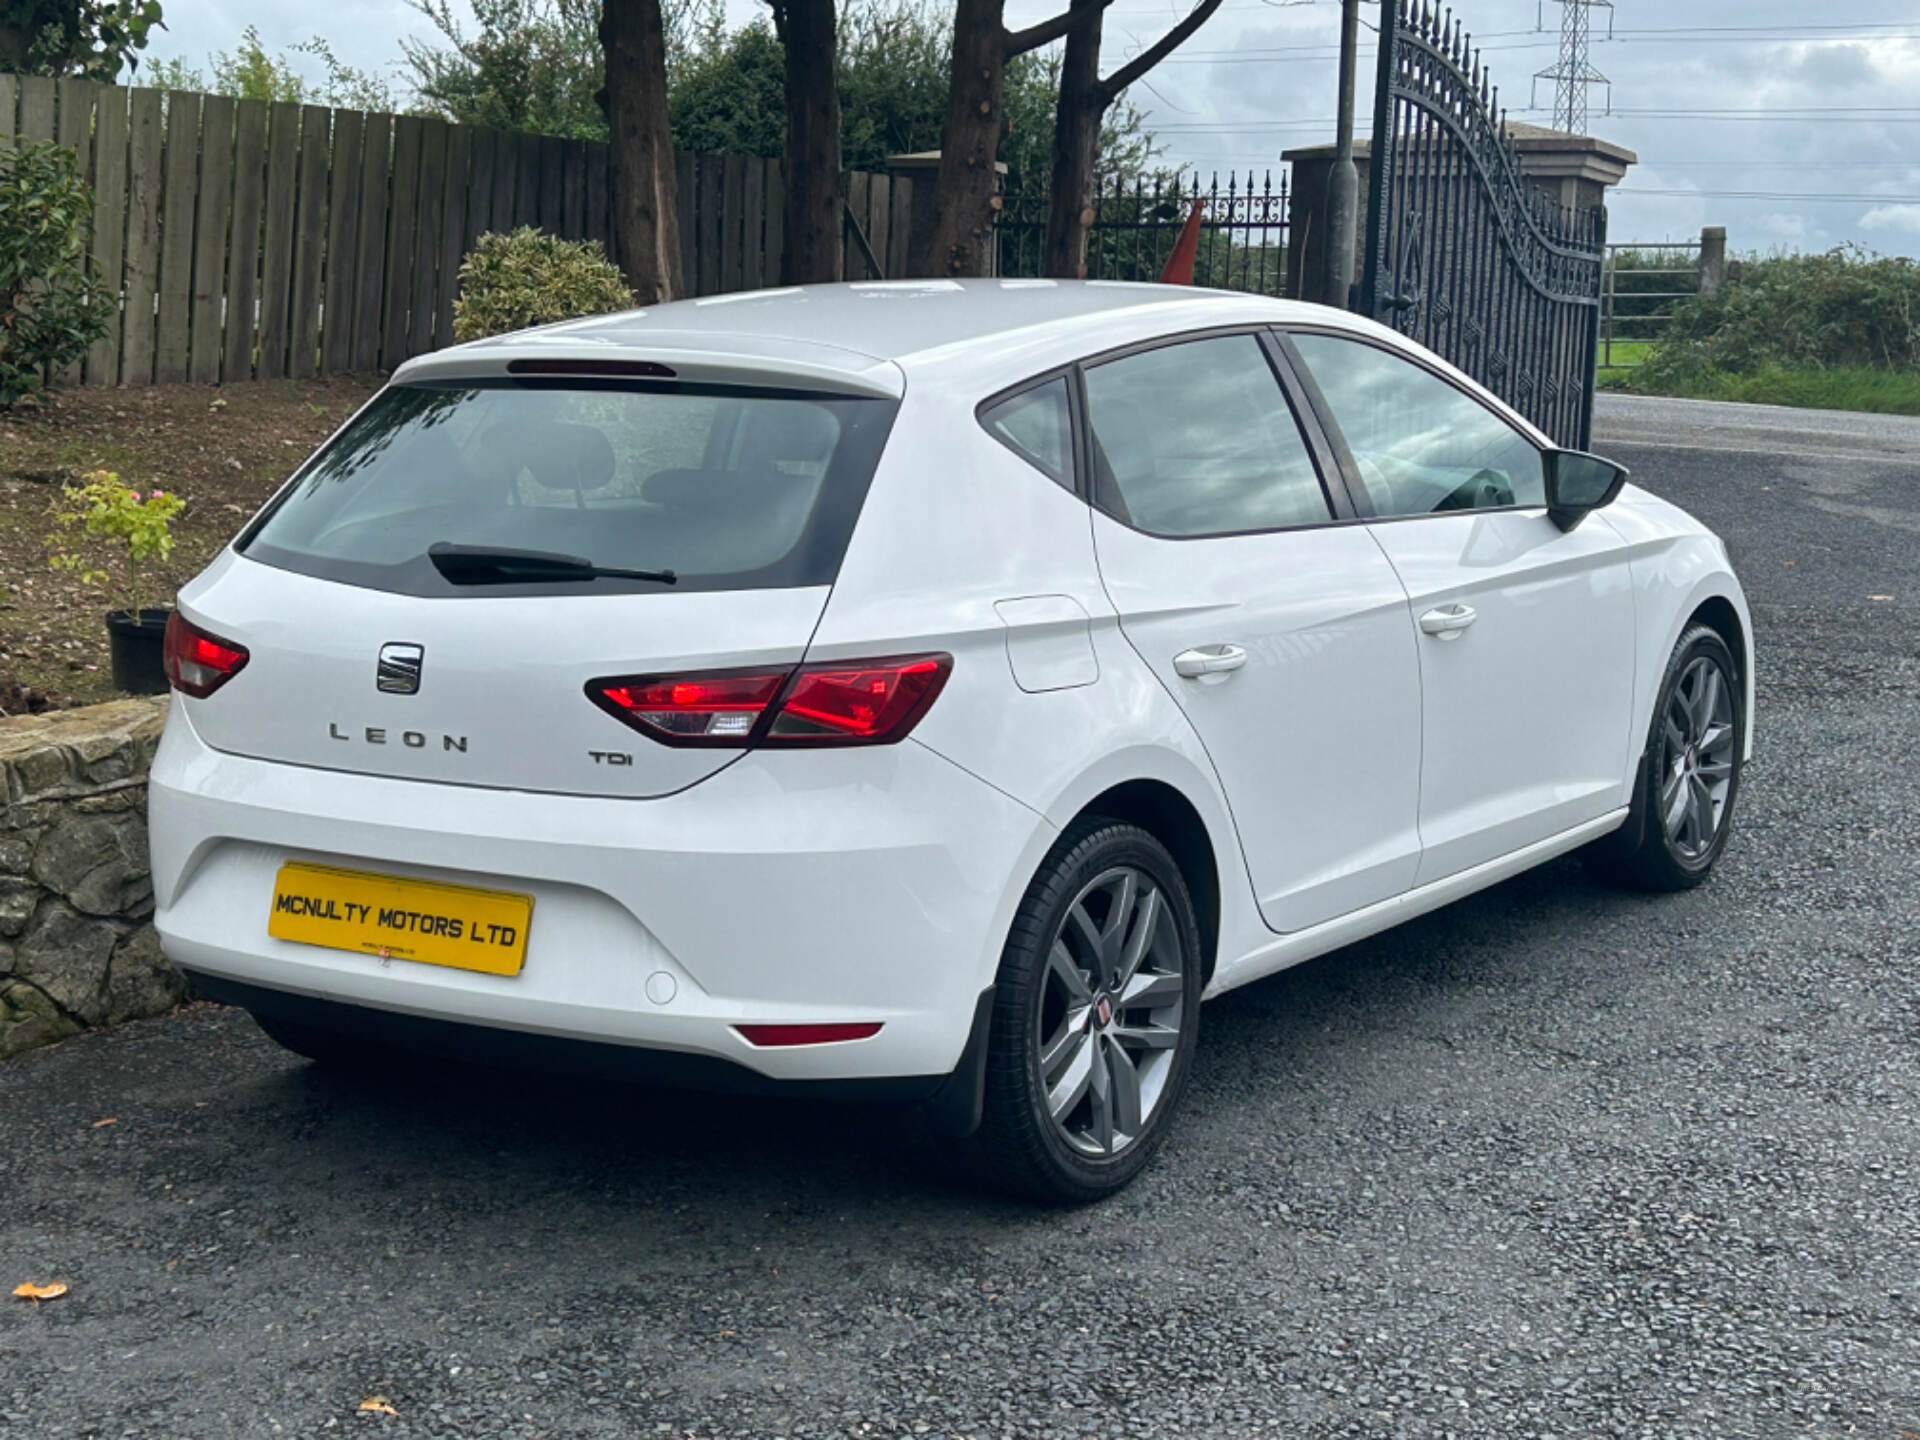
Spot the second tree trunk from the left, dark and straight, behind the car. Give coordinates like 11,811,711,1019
774,0,843,284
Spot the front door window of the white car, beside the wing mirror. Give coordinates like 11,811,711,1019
1292,334,1548,516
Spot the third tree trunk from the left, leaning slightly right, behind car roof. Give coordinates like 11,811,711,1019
920,0,1006,275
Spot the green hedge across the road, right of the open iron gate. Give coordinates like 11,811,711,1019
1634,246,1920,392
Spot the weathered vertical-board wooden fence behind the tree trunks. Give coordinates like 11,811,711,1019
0,75,912,386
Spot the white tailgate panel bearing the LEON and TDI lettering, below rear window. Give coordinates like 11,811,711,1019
168,551,828,799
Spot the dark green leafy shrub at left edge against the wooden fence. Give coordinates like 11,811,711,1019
0,142,115,409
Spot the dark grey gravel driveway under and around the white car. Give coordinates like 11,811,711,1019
0,399,1920,1440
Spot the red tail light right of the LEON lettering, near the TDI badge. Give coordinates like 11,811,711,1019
588,655,954,749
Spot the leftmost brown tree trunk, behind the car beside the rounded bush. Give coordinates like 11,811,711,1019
599,0,684,305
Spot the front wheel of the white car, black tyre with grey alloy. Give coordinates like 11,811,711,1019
1588,626,1747,891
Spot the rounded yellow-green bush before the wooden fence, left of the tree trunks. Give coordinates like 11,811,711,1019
453,225,634,340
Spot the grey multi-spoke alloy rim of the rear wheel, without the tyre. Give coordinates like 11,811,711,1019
1033,866,1187,1158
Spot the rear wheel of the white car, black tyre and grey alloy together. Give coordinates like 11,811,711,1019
979,818,1202,1204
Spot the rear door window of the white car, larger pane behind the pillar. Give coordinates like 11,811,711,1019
1087,334,1332,536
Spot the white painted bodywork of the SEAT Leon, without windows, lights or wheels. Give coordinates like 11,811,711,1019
150,282,1753,1079
